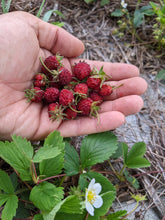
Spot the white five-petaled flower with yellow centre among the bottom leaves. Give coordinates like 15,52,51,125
85,179,103,216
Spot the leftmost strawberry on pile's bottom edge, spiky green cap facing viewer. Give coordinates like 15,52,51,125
48,103,65,121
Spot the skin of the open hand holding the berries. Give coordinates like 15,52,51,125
0,12,147,140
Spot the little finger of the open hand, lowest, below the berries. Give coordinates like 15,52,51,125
58,111,125,137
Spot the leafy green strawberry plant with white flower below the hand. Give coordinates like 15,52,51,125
0,131,149,220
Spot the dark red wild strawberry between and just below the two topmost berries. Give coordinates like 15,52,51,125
58,67,72,86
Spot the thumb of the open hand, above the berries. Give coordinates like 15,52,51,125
36,14,84,57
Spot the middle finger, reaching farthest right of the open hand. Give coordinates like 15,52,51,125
105,77,147,100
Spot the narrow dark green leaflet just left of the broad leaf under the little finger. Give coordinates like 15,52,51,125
64,142,80,176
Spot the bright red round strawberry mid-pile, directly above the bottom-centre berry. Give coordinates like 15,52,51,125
59,89,74,106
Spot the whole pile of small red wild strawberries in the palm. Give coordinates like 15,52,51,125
25,54,118,121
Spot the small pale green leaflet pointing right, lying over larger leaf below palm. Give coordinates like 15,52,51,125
33,145,61,163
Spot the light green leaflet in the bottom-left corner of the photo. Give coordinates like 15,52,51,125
1,195,18,220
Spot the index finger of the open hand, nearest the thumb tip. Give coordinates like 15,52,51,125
70,59,139,80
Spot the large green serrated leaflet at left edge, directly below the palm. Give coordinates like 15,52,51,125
0,135,33,181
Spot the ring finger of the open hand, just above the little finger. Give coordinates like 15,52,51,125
99,95,143,116
